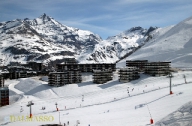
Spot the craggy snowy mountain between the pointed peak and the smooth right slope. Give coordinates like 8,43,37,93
79,27,157,63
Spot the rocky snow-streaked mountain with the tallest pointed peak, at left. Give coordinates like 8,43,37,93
0,14,102,65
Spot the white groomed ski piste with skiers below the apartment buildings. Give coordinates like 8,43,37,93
0,71,192,126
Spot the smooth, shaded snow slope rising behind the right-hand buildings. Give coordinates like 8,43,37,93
117,17,192,67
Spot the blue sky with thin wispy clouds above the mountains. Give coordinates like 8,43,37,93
0,0,192,39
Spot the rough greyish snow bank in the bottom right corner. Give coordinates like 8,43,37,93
156,101,192,126
